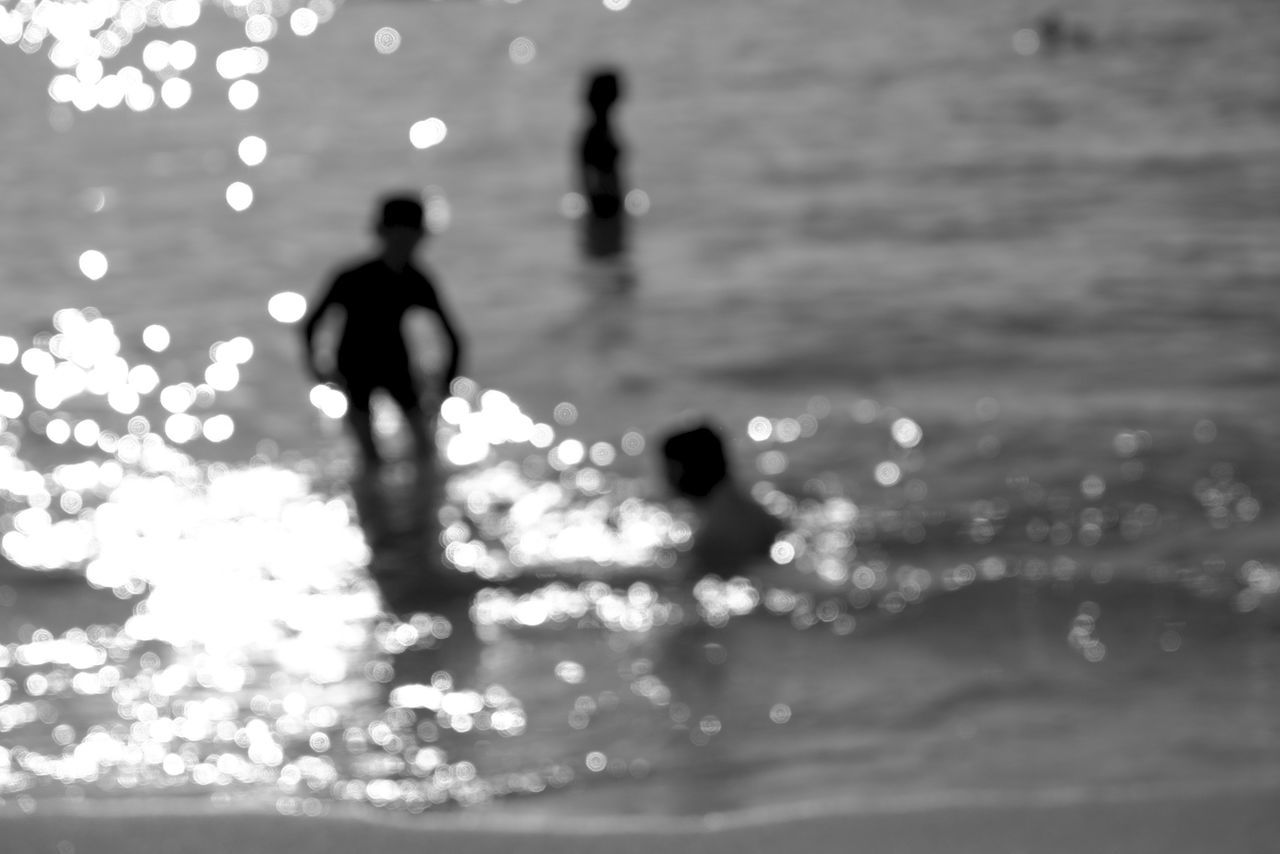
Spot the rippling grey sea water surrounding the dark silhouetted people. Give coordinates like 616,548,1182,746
0,0,1280,816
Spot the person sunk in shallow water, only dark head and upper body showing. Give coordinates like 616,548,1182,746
662,424,785,570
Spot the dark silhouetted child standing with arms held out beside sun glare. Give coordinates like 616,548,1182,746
302,196,462,474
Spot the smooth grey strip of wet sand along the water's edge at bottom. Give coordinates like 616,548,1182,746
0,789,1280,854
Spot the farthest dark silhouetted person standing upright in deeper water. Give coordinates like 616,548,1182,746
579,68,626,259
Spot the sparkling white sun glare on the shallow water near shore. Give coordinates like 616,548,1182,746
0,303,1280,812
